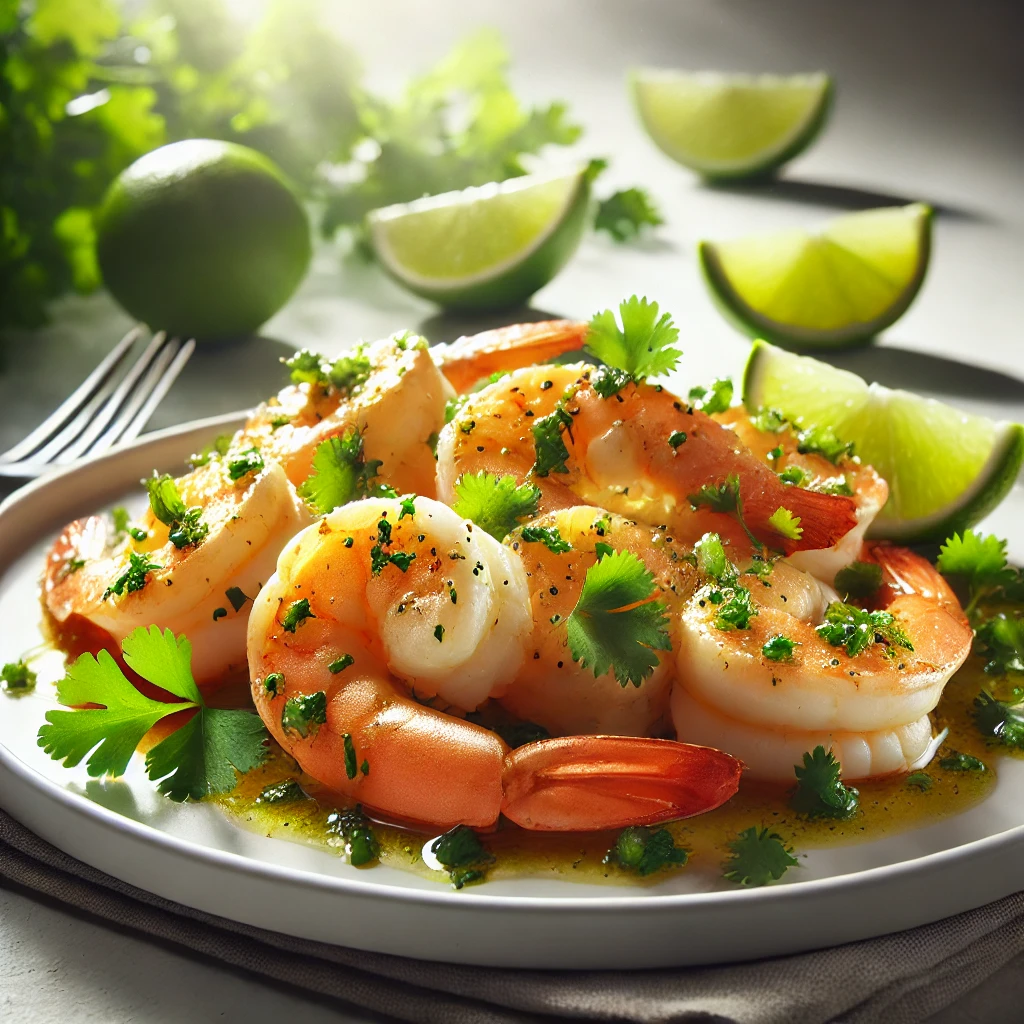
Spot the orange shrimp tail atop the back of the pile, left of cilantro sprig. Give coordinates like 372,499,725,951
437,321,588,392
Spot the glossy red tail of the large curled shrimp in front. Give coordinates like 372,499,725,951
502,736,743,831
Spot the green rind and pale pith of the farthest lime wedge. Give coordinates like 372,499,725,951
629,69,836,182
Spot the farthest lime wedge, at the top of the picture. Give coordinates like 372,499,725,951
632,70,833,179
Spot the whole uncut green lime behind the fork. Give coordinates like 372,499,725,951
96,139,311,339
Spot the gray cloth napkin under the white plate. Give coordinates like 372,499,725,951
0,811,1024,1024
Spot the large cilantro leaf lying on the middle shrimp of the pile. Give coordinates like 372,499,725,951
565,551,672,686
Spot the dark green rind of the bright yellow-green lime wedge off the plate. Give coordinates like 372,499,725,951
697,203,933,351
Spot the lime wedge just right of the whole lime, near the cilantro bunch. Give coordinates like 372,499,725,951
369,170,589,309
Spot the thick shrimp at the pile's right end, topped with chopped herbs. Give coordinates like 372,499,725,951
672,543,972,780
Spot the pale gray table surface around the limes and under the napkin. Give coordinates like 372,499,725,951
0,0,1024,1024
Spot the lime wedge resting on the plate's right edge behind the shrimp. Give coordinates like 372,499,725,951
743,341,1024,544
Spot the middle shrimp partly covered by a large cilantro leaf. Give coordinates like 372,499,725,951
501,506,697,736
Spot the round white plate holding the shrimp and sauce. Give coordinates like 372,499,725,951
0,417,1024,968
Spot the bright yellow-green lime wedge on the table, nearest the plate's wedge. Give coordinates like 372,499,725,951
699,203,932,348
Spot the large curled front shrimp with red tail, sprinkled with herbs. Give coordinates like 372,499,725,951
248,498,739,830
